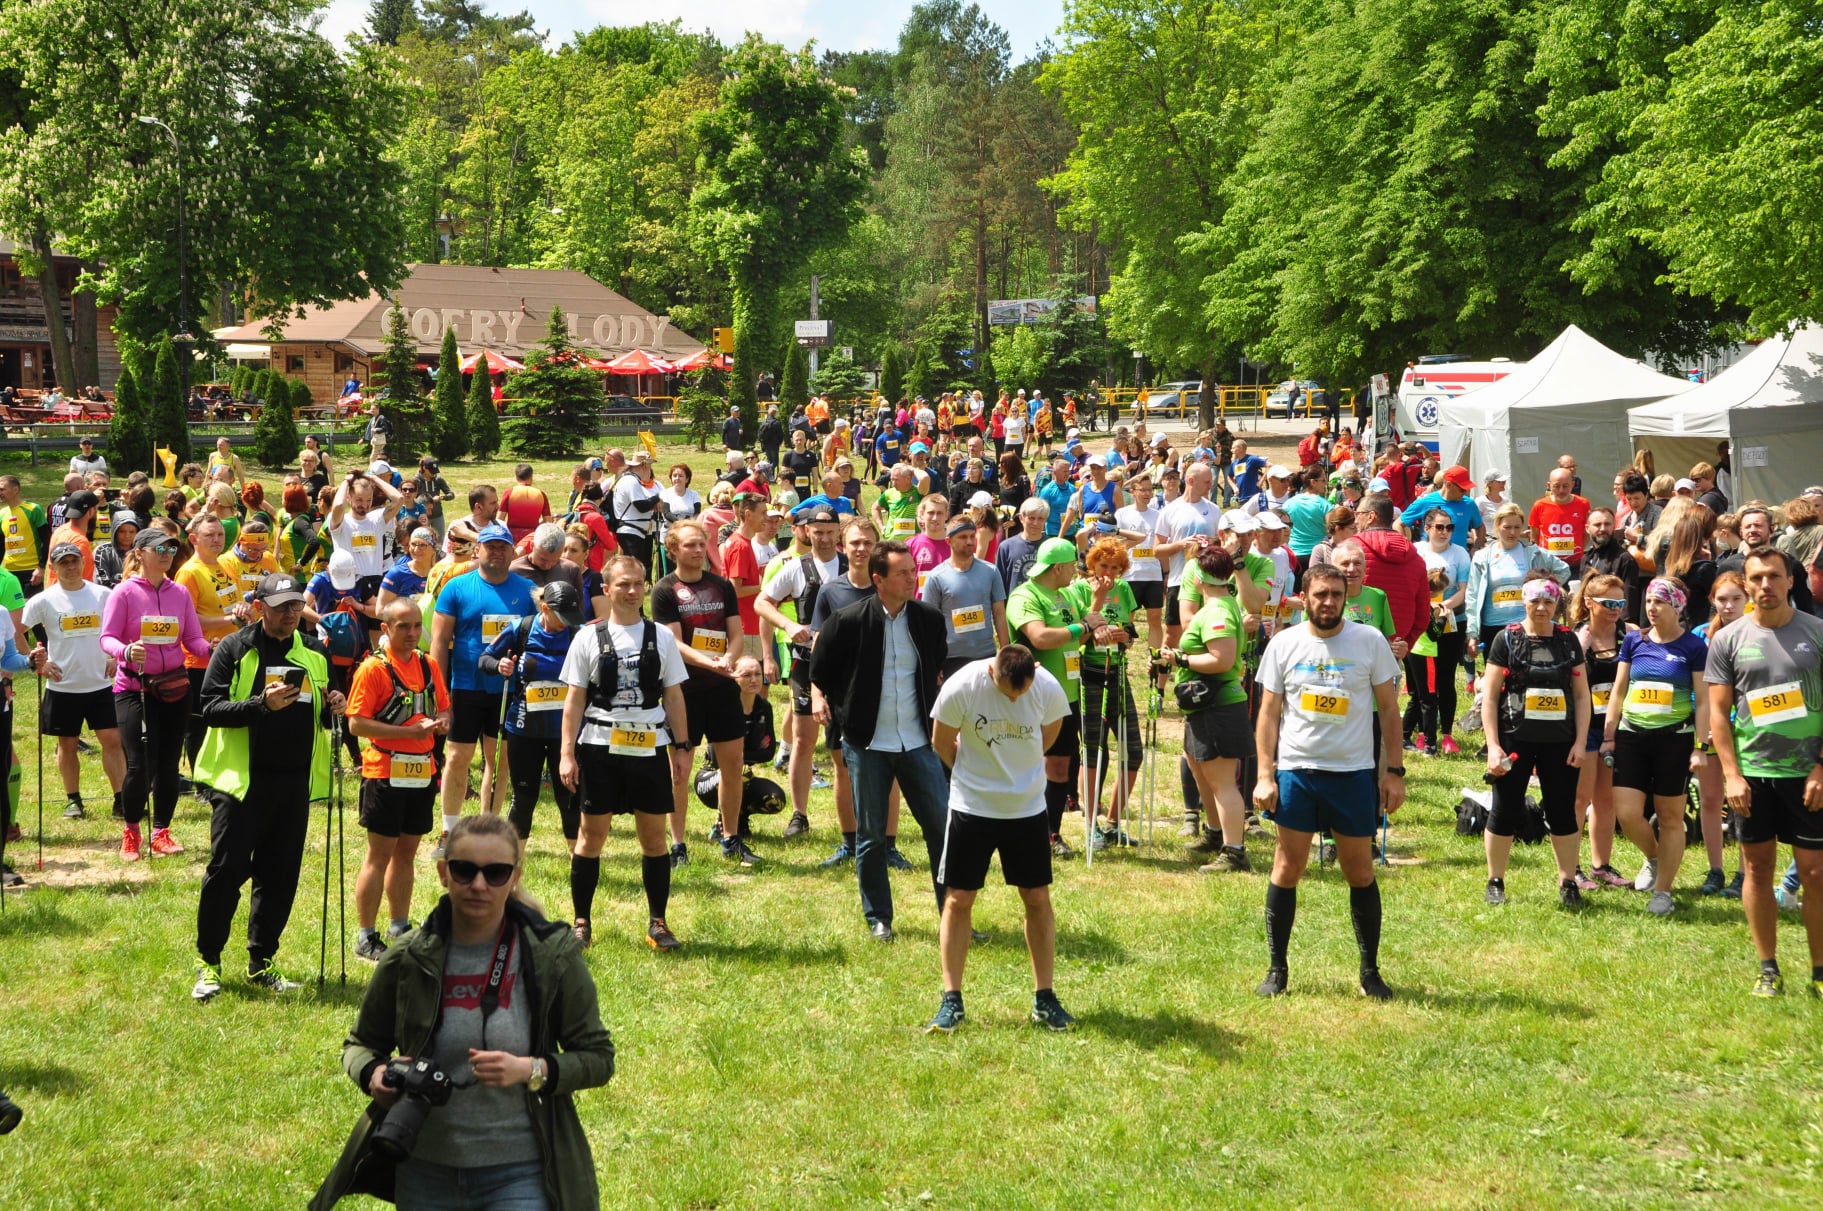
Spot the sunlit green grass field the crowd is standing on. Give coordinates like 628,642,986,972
0,432,1823,1207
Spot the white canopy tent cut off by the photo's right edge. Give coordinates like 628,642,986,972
1626,325,1823,503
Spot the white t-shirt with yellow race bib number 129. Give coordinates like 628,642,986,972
1258,620,1398,773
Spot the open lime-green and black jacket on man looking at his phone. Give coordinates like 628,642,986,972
195,622,334,801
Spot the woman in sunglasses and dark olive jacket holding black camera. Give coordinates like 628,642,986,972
310,813,614,1211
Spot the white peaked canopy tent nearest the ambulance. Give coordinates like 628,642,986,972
1437,325,1695,502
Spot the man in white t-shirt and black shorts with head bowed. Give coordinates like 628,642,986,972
924,646,1076,1034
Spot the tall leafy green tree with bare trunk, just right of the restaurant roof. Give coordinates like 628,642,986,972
691,35,866,445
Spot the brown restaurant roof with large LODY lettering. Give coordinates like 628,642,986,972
217,264,702,361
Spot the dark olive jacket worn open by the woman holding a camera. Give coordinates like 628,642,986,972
310,895,614,1211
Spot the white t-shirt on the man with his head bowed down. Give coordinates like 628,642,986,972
930,660,1070,821
